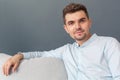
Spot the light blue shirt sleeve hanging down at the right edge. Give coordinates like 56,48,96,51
105,38,120,80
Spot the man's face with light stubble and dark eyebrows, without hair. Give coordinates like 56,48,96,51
64,10,91,41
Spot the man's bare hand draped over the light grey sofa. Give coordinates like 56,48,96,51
3,54,23,76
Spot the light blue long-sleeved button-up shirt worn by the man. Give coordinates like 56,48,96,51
22,34,120,80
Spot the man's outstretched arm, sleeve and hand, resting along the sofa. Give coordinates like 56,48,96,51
3,46,66,76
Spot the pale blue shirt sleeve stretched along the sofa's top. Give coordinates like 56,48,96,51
21,45,66,59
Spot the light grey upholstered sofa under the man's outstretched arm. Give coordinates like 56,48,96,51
0,53,67,80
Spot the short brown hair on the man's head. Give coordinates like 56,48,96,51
63,3,89,24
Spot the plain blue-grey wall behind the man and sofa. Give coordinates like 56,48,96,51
0,0,120,55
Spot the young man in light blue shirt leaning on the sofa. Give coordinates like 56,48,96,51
3,3,120,80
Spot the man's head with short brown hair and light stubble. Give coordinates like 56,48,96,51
63,3,91,44
